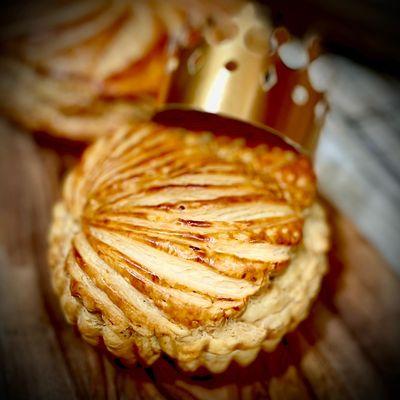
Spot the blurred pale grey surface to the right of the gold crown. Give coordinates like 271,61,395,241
314,55,400,274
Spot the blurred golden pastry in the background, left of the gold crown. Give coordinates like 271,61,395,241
0,0,239,140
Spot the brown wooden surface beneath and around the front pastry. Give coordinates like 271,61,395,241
0,121,400,400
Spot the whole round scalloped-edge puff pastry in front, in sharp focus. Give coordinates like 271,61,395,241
50,123,328,372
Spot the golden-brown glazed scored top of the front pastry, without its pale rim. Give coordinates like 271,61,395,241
54,124,315,331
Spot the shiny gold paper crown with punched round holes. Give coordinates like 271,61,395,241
160,3,327,152
